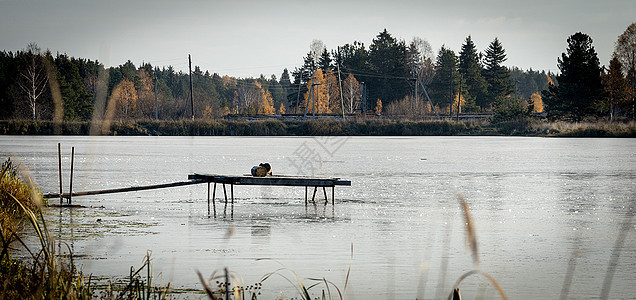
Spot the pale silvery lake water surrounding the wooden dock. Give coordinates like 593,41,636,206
0,136,636,299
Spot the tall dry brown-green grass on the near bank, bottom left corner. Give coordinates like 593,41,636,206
0,159,169,299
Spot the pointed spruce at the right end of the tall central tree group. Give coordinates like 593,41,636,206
482,38,512,108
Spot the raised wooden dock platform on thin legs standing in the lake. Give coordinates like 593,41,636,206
188,174,351,218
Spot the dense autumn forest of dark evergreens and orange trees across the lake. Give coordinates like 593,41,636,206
0,24,636,121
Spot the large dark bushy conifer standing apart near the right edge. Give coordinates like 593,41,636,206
544,32,603,121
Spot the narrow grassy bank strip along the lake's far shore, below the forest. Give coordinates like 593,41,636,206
0,118,636,138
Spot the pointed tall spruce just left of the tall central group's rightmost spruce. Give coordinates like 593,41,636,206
459,36,487,107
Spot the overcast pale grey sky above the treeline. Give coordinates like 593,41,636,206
0,0,636,77
